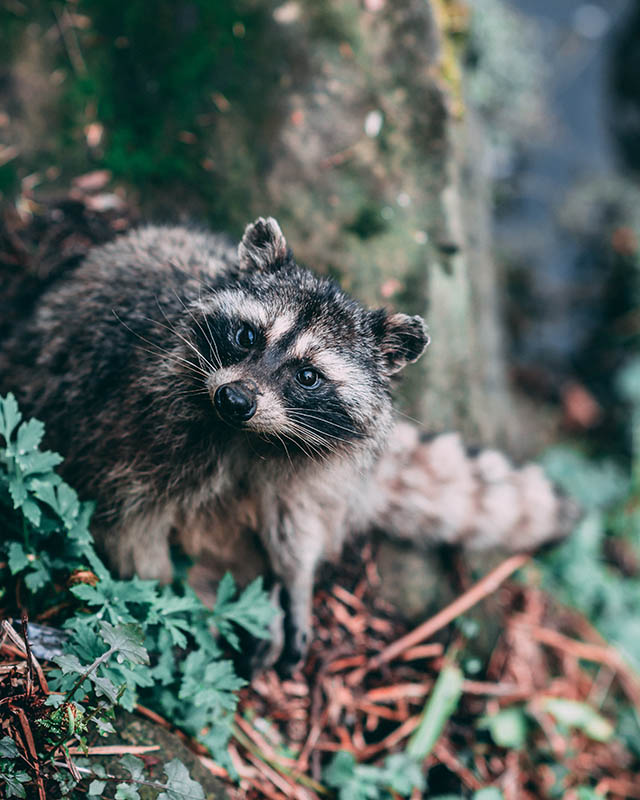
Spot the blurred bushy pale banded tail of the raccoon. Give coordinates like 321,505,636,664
364,423,580,551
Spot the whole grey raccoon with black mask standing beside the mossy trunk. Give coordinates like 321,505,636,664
0,218,567,661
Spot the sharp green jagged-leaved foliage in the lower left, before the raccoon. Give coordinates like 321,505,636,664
0,395,274,800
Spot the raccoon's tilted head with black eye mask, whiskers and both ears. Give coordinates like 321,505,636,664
185,218,428,457
